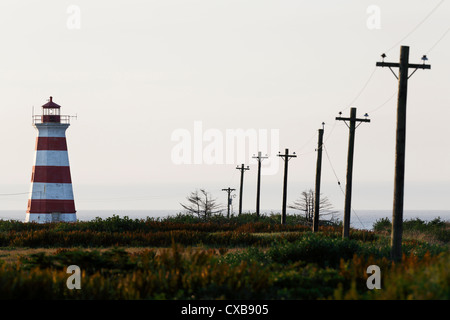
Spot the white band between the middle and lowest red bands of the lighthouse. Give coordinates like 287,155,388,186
30,182,73,200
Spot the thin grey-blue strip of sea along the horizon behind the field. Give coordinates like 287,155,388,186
0,210,450,230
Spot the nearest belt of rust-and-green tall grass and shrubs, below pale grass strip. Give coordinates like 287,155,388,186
0,240,450,300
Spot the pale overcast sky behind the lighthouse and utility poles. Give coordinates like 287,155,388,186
0,0,450,218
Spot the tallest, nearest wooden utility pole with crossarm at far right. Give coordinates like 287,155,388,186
376,46,431,261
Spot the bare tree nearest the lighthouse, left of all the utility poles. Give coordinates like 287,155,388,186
180,189,223,220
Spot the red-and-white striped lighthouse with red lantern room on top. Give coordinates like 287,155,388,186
25,97,77,223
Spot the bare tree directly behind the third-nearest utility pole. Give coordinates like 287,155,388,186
288,189,338,225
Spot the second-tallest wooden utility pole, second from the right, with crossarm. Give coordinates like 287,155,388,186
336,108,370,239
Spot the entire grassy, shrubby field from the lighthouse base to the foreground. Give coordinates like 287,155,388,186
0,214,450,300
